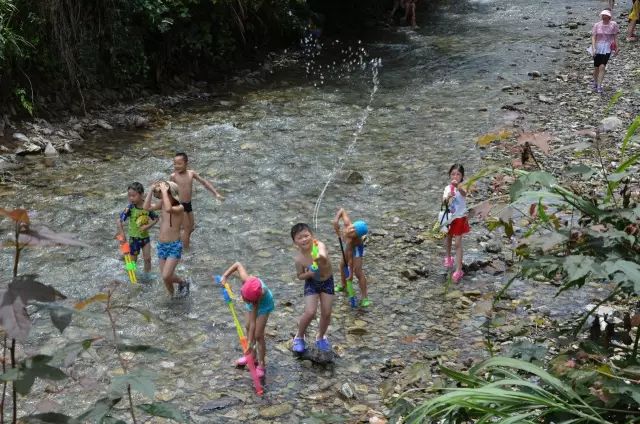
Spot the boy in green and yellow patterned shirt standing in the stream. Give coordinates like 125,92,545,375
116,182,158,273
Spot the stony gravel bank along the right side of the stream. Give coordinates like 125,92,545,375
381,2,640,418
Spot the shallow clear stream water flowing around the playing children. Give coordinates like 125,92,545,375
0,0,600,422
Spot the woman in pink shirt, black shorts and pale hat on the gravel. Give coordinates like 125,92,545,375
591,9,620,93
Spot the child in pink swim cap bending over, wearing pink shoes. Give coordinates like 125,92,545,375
222,262,275,378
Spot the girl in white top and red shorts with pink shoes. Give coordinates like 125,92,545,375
442,163,470,283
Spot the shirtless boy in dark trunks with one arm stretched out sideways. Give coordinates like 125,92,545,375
170,153,224,250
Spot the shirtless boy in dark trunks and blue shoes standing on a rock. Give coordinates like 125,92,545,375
291,223,333,353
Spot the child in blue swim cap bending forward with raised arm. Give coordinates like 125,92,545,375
333,208,371,308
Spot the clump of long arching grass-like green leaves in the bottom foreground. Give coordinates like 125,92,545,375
404,357,613,424
